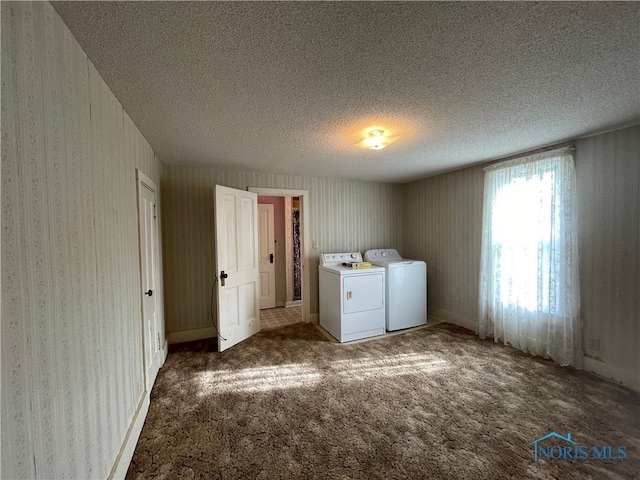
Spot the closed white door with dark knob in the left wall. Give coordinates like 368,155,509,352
138,172,164,391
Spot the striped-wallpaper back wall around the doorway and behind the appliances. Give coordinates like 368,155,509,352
162,166,402,332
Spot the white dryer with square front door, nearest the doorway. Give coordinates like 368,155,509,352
318,252,385,343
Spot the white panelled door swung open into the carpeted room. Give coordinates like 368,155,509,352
215,185,260,352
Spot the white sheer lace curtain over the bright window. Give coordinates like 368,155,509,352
478,148,582,367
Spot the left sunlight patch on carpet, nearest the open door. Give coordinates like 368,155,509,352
198,363,321,396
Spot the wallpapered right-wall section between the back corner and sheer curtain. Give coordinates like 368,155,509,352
400,167,484,330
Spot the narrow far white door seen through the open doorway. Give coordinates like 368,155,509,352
258,203,276,310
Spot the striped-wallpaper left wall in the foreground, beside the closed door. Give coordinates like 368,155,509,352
0,2,162,479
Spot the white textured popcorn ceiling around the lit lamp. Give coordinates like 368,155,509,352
54,2,640,183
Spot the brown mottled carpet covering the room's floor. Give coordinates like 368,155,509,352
127,323,640,479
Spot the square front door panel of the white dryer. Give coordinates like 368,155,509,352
342,272,384,313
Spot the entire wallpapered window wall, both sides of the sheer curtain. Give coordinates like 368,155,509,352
402,126,640,388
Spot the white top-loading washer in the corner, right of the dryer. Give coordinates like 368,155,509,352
364,248,427,331
